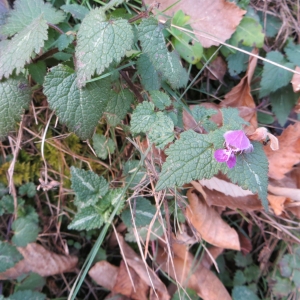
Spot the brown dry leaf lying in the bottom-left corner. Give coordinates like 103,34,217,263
0,243,78,280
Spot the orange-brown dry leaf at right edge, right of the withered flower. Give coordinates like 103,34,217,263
264,122,300,180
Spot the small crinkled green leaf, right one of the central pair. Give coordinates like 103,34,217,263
148,112,174,149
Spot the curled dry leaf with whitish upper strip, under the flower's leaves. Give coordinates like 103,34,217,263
192,175,262,210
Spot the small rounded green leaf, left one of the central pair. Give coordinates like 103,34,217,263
130,101,156,133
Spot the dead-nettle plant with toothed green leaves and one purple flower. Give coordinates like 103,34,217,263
0,0,268,292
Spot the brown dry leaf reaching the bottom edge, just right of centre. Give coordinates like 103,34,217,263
156,238,231,300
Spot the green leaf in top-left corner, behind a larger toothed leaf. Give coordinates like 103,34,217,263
1,0,65,36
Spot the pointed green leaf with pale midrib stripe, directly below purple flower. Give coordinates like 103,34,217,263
226,142,269,211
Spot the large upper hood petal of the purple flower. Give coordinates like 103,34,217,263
224,130,252,152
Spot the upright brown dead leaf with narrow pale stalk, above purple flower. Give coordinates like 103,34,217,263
221,48,258,133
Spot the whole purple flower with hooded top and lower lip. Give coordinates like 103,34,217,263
214,130,253,169
